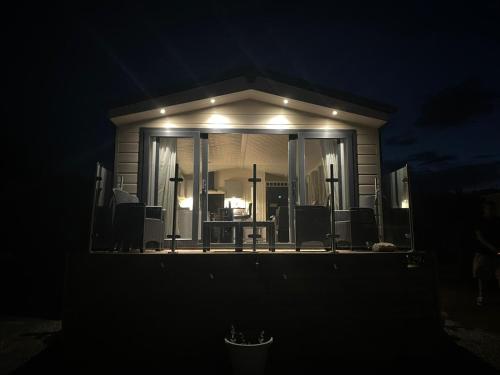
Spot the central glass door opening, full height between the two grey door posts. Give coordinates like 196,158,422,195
200,134,296,248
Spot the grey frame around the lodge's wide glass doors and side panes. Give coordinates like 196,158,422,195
137,128,359,247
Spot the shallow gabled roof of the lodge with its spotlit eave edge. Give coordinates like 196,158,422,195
109,71,396,127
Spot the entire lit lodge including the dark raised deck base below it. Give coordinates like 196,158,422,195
63,74,440,373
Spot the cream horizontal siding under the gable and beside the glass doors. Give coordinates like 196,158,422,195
115,100,380,206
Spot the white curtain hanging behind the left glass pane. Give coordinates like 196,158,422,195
158,137,179,238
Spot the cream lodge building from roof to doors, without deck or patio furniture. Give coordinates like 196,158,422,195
103,72,404,249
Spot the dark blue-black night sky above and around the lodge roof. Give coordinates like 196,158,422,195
2,1,500,188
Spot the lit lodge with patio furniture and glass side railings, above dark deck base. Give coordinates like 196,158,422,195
92,72,412,251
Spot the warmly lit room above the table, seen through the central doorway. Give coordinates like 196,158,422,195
208,133,288,241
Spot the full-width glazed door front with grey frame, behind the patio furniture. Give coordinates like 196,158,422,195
139,129,358,248
